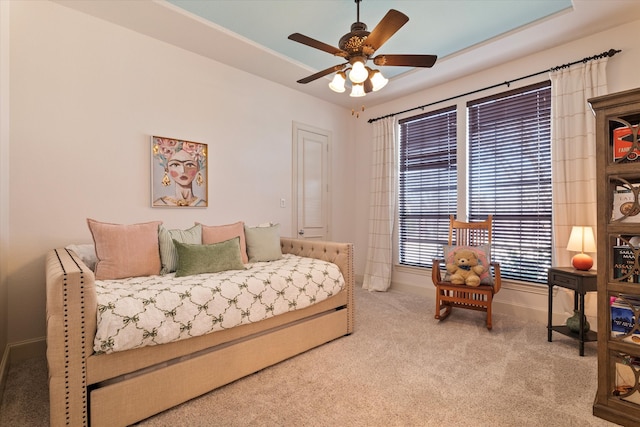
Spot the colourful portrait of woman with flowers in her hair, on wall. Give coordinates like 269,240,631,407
151,136,208,208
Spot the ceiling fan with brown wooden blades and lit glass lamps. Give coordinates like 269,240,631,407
289,0,438,96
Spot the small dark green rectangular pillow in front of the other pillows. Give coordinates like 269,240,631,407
173,237,244,277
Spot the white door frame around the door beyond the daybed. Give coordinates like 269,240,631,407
291,121,333,240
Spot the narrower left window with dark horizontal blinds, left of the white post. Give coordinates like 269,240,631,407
398,106,458,267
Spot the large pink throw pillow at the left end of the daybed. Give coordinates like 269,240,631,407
87,218,162,280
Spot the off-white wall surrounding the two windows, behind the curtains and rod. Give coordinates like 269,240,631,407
355,17,640,325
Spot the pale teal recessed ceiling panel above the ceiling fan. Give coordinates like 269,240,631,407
169,0,572,77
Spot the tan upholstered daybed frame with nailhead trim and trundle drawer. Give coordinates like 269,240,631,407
46,222,354,426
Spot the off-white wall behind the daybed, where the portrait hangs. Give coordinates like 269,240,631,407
3,1,355,343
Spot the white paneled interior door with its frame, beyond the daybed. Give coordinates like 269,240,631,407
293,123,331,240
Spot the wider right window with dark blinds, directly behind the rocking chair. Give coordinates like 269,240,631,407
467,82,552,283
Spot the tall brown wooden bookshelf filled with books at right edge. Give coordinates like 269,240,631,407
589,89,640,426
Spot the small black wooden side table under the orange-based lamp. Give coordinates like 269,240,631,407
547,267,598,356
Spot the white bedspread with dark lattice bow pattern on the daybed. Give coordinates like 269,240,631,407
94,254,344,353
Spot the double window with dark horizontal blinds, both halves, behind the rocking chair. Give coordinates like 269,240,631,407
398,82,552,283
